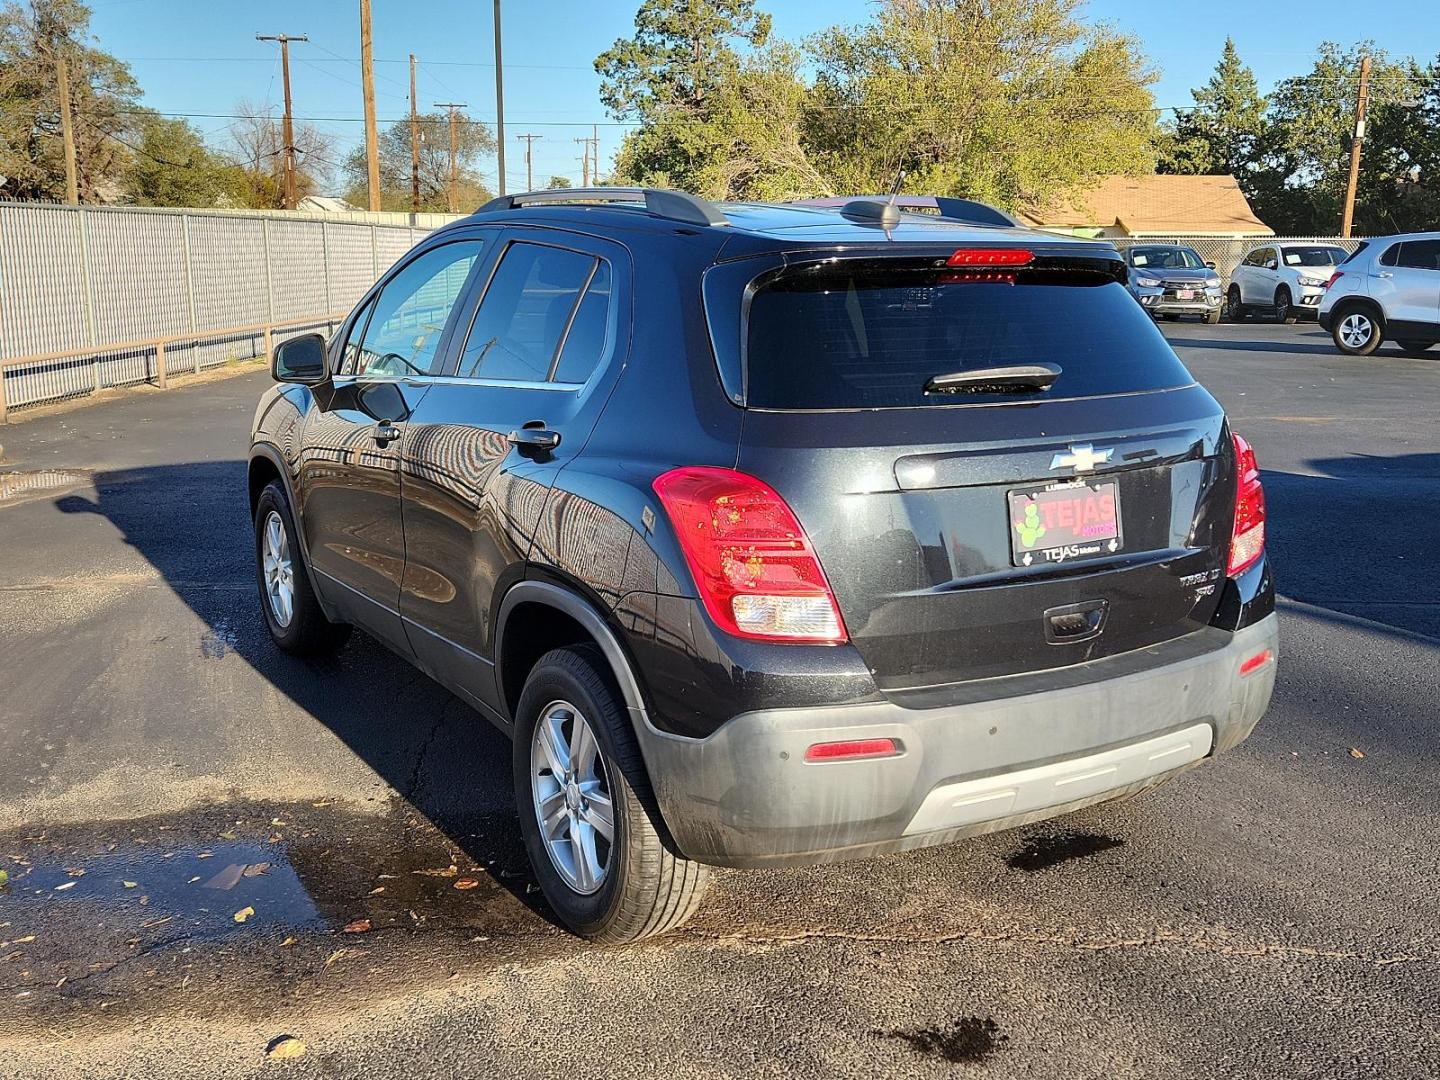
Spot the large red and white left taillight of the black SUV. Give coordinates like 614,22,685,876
655,467,847,645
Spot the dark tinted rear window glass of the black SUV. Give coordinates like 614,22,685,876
746,268,1192,409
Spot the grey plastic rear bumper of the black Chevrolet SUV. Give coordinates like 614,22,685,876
641,615,1279,867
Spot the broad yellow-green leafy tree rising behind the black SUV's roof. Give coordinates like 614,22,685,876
806,0,1156,209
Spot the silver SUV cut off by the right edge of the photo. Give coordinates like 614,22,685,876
1319,232,1440,356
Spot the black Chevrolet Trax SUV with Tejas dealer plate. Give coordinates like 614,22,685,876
249,189,1277,942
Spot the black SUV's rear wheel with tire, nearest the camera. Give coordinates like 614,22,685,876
513,645,710,945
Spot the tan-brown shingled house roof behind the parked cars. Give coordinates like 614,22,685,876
1020,174,1274,238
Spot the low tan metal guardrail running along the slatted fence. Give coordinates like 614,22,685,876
0,311,347,423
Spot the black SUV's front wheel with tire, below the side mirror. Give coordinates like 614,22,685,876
255,481,350,657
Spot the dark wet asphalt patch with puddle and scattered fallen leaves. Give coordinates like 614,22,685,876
0,801,561,1032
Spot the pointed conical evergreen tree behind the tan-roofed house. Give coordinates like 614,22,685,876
1161,37,1266,178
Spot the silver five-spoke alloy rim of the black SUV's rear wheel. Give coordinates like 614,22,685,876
530,701,615,896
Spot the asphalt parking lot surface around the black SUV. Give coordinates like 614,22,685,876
0,323,1440,1077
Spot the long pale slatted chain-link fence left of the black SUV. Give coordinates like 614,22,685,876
0,203,429,416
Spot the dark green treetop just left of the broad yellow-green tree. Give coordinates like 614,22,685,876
595,0,770,120
